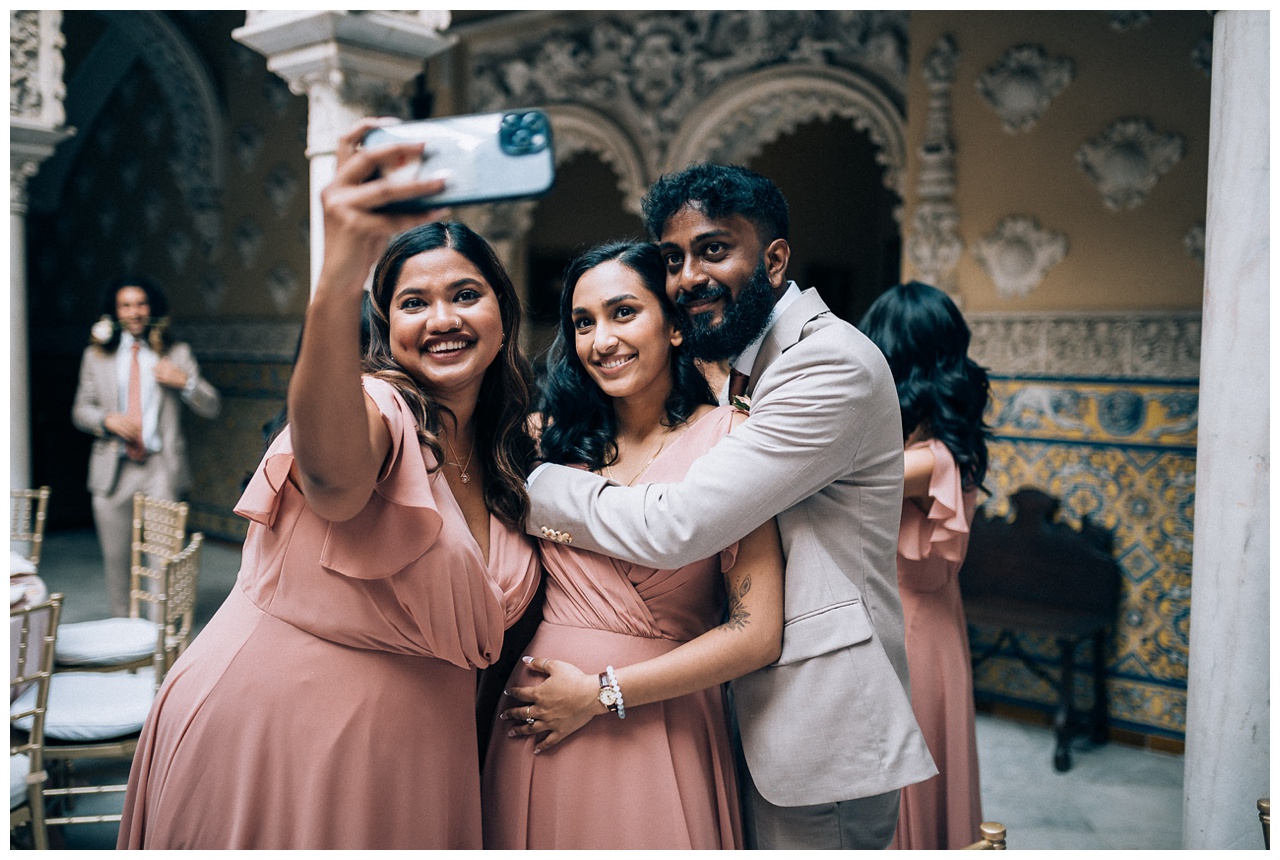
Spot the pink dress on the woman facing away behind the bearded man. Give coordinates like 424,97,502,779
890,439,982,850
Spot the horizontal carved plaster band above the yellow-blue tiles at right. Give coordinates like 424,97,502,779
965,311,1201,380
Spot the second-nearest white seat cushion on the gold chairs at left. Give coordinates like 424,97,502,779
10,672,155,744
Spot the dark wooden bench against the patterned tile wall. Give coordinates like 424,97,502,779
960,488,1120,770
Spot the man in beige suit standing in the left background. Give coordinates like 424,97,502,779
72,278,221,617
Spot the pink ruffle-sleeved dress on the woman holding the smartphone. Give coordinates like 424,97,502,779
119,378,539,848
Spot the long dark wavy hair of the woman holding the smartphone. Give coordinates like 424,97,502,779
364,221,534,531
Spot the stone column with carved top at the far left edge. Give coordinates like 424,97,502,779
9,10,73,489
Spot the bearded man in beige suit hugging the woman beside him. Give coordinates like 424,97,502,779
529,165,937,848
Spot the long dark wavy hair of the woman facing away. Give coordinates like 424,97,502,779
858,280,991,489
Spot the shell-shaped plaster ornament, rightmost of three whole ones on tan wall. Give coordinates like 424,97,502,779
1075,119,1187,210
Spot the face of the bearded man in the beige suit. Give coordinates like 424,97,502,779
658,205,790,361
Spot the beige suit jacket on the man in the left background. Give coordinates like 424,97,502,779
72,343,221,495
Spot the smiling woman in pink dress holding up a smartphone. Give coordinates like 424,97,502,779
119,120,539,848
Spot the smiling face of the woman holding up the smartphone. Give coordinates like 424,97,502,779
389,248,503,404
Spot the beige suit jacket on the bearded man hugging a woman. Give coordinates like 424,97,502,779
529,289,937,806
